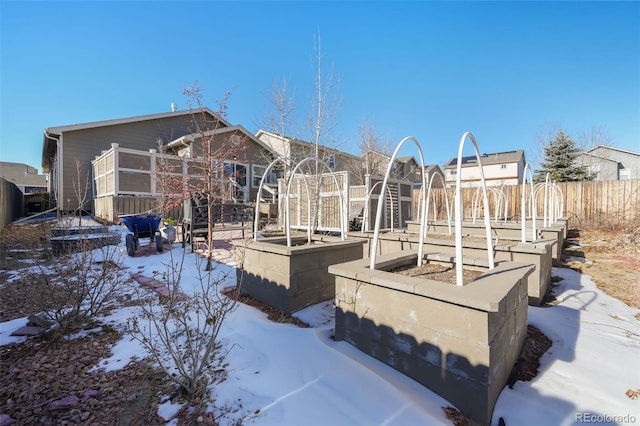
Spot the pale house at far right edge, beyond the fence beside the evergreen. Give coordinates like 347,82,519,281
576,145,640,180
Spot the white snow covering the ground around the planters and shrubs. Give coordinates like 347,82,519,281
0,227,640,425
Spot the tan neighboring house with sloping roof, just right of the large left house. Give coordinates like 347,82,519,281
256,130,360,178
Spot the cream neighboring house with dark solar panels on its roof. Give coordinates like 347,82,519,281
444,149,526,187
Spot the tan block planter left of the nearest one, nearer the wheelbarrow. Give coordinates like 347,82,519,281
237,236,365,313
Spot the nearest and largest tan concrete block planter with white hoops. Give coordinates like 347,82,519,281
329,252,533,424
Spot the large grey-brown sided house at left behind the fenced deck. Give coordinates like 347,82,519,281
42,108,276,213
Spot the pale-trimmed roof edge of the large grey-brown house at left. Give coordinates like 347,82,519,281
42,107,230,172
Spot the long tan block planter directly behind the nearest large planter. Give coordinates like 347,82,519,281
349,232,553,306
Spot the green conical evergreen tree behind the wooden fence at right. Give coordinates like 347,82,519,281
534,130,593,182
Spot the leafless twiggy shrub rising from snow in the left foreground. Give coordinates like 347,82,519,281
128,243,239,402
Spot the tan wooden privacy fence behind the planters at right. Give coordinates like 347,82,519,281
413,179,640,227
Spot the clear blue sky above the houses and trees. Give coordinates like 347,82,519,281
0,1,640,168
